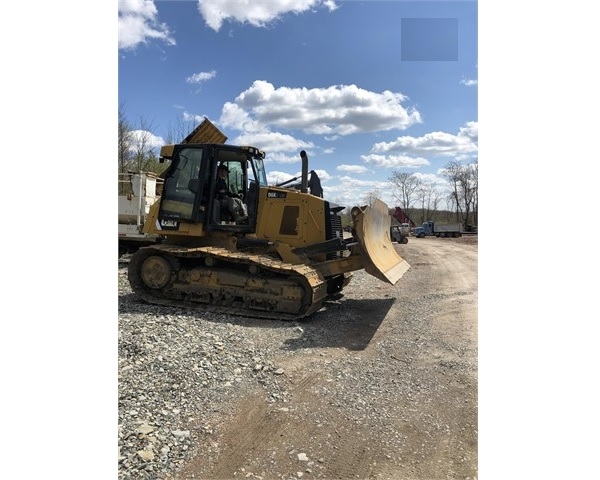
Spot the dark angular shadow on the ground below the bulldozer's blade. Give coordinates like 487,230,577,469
284,298,395,350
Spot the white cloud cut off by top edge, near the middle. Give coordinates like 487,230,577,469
198,0,337,32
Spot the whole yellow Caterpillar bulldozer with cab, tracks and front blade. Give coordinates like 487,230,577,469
128,142,410,320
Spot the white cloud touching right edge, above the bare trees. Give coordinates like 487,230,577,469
371,122,478,156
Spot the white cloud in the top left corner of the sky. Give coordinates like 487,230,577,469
118,0,175,50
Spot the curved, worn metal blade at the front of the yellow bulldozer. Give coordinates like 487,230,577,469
351,199,410,285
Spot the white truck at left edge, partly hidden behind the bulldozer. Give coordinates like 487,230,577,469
118,172,163,257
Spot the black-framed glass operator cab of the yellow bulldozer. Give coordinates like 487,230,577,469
159,144,267,232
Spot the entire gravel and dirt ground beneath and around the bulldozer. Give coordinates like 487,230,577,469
118,236,478,480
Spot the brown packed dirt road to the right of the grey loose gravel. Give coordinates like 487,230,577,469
173,237,478,480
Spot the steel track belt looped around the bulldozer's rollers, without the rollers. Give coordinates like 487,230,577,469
129,245,328,320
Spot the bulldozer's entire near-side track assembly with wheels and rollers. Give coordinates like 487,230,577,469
128,245,347,320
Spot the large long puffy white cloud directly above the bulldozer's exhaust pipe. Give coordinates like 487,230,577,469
221,80,421,136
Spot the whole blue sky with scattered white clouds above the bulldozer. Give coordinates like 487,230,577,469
118,0,478,210
